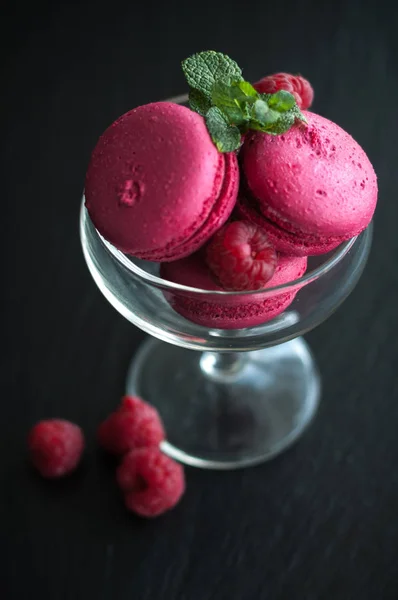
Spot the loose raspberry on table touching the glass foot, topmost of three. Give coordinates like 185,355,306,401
98,396,165,454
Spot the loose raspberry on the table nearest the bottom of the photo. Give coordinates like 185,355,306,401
116,447,185,517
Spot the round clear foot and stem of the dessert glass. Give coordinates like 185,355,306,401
127,337,320,469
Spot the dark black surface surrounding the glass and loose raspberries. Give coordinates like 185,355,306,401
0,0,398,600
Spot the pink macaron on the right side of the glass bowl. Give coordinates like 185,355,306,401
237,112,377,256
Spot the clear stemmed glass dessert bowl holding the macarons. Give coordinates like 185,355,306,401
80,204,372,469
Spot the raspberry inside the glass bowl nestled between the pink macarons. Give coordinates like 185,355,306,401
206,221,277,291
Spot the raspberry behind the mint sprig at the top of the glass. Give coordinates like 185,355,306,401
253,73,314,110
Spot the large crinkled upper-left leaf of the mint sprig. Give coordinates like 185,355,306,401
182,50,243,99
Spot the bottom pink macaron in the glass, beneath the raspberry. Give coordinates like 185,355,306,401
160,250,307,329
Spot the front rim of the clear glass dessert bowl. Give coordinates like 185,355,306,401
80,203,360,297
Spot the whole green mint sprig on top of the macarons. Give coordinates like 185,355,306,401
182,50,306,152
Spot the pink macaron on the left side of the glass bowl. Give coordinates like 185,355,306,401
85,102,239,262
